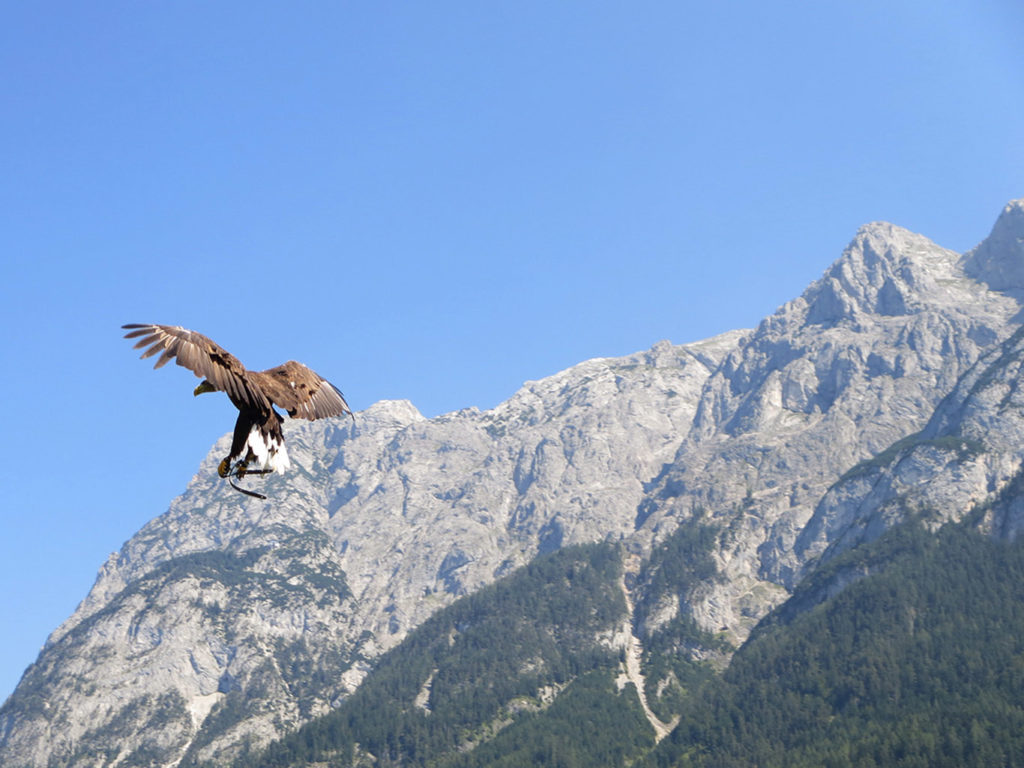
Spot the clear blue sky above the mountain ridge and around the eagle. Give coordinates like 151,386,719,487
0,0,1024,698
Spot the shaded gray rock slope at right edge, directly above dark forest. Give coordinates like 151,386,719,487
797,321,1024,563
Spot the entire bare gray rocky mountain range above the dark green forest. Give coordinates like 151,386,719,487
6,201,1024,766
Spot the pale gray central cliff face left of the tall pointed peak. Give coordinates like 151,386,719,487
323,334,738,654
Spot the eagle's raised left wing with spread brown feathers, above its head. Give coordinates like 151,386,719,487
122,323,272,412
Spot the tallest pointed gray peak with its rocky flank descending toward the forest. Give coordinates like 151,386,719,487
644,203,1021,642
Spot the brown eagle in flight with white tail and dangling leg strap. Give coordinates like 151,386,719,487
122,323,354,496
